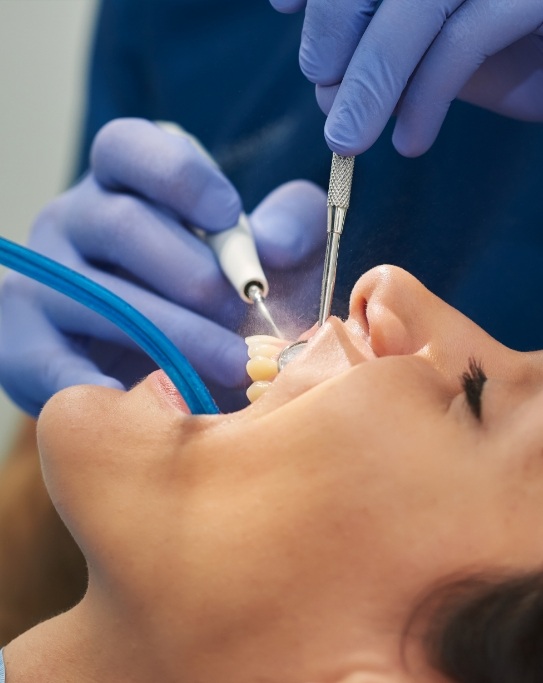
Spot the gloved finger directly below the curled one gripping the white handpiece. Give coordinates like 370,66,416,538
32,176,243,325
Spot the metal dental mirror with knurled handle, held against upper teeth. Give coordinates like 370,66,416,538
277,152,354,371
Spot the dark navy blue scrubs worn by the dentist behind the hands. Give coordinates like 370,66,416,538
78,0,543,349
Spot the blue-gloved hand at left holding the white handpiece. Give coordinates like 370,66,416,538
0,119,326,415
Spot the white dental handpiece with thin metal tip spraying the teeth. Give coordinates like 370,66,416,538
157,121,282,337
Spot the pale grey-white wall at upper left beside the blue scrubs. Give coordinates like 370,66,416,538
0,0,97,454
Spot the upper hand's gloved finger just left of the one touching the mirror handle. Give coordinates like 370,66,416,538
300,0,378,85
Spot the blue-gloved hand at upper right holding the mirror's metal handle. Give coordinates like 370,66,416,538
270,0,543,156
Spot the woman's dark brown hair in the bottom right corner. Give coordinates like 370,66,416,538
408,573,543,683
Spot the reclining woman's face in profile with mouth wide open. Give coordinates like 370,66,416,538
39,267,543,681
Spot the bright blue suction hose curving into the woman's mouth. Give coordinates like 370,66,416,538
0,237,219,415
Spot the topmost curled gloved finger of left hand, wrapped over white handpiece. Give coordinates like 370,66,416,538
91,119,242,231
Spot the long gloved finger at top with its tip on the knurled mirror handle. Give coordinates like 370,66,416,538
325,0,464,156
